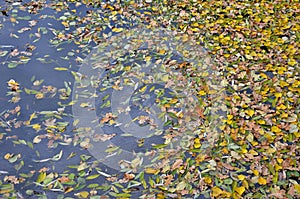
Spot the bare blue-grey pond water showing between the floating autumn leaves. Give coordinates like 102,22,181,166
0,1,216,199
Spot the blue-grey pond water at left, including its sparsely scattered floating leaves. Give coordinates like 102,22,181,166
0,1,220,198
